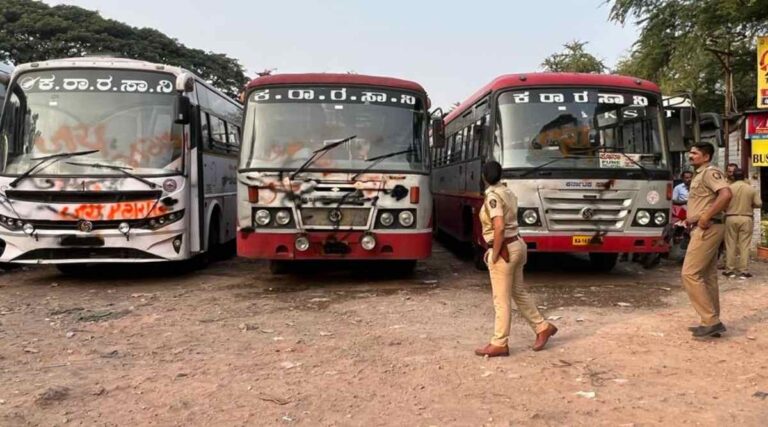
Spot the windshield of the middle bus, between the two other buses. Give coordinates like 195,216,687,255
241,87,427,171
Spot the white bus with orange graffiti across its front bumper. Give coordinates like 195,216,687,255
0,57,242,271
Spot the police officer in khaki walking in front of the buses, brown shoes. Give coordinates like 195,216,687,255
475,162,557,357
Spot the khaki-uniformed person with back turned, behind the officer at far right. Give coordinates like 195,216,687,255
723,169,763,279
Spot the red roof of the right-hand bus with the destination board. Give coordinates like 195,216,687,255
445,73,660,123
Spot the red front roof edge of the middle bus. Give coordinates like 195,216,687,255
247,73,426,93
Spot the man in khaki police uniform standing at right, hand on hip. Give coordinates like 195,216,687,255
682,143,731,337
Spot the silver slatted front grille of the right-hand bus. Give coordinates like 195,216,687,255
540,190,635,231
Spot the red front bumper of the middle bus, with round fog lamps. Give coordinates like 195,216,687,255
237,230,432,260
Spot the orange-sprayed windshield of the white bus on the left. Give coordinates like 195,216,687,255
0,69,182,175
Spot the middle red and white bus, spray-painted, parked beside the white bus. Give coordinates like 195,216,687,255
237,74,432,272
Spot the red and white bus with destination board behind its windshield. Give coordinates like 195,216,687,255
432,73,672,270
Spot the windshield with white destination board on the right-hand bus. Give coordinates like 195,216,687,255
493,89,668,169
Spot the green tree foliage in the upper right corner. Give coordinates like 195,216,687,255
607,0,768,111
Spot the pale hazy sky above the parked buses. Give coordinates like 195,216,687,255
46,0,637,108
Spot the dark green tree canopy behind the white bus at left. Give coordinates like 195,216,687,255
0,0,248,97
